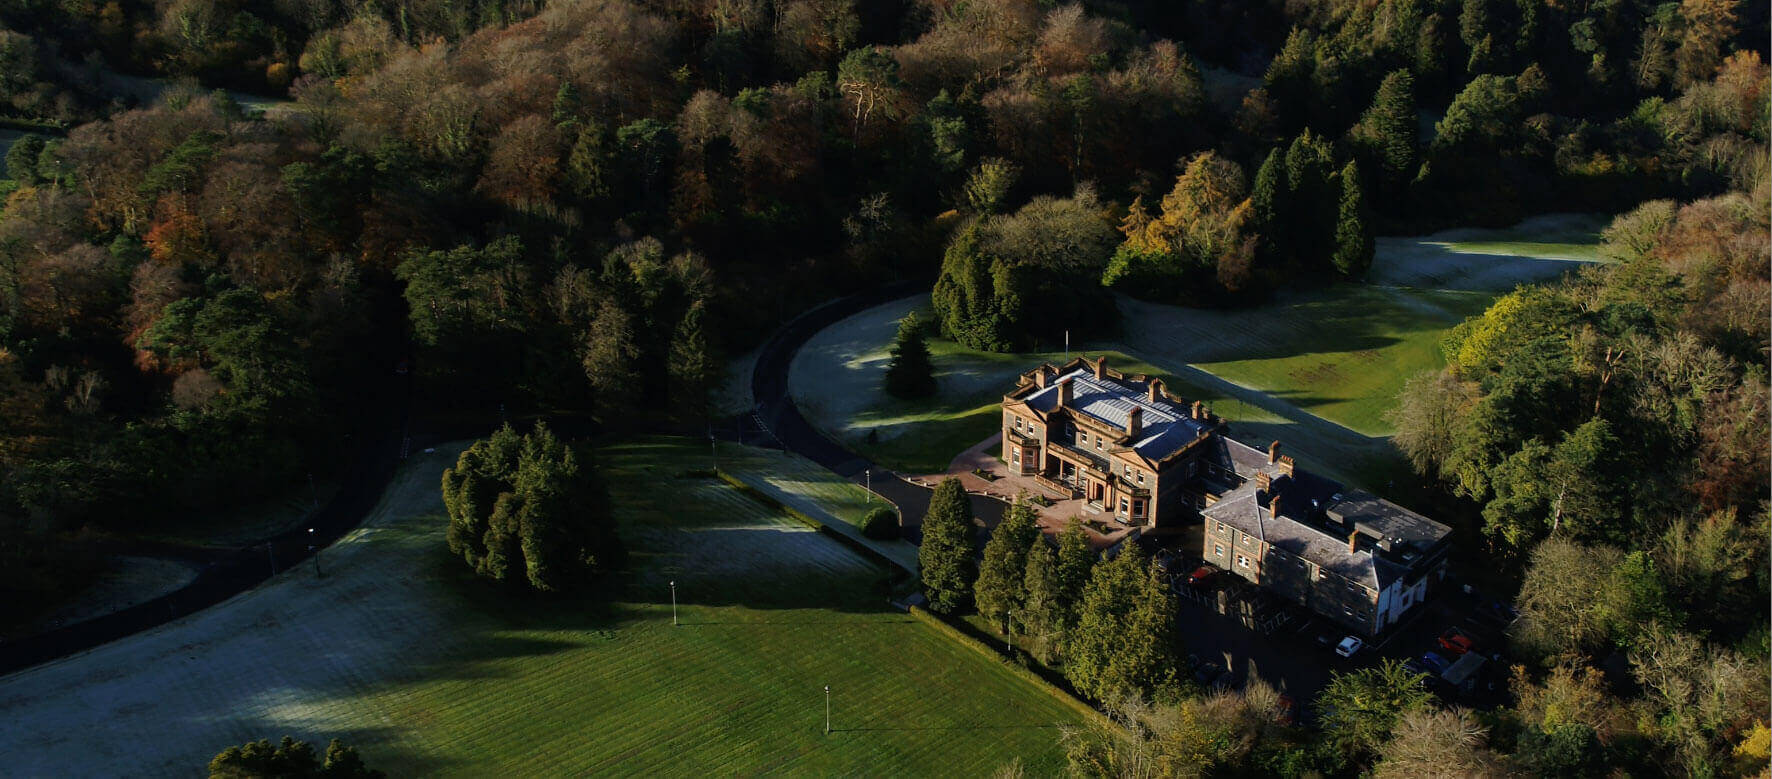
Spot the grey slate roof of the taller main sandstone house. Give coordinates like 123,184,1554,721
1024,368,1210,460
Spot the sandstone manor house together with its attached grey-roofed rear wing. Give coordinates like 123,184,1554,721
1003,356,1451,636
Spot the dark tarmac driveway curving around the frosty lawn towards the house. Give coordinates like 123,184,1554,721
751,282,1003,542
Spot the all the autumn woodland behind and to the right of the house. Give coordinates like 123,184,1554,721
0,0,1768,775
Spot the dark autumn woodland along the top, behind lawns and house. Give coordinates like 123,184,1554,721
0,0,1767,694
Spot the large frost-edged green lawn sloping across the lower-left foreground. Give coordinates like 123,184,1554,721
0,439,1076,775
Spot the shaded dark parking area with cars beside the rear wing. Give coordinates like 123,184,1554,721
1157,536,1513,719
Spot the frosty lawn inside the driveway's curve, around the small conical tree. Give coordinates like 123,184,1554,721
789,296,1274,474
